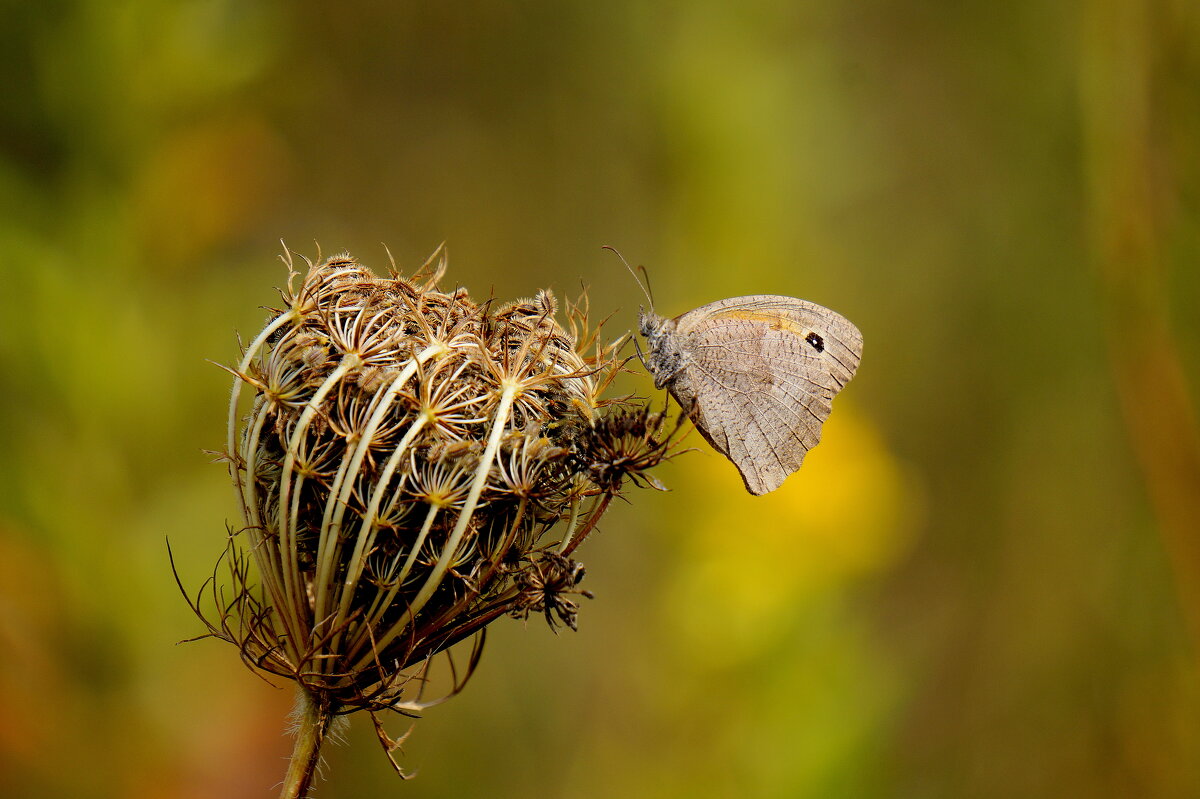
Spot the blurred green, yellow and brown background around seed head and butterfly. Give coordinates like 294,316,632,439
0,0,1200,799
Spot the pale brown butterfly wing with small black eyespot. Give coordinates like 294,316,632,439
668,295,863,494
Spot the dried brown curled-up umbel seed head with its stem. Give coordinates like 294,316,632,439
182,247,673,795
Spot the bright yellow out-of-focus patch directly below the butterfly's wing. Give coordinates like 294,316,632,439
664,405,920,661
